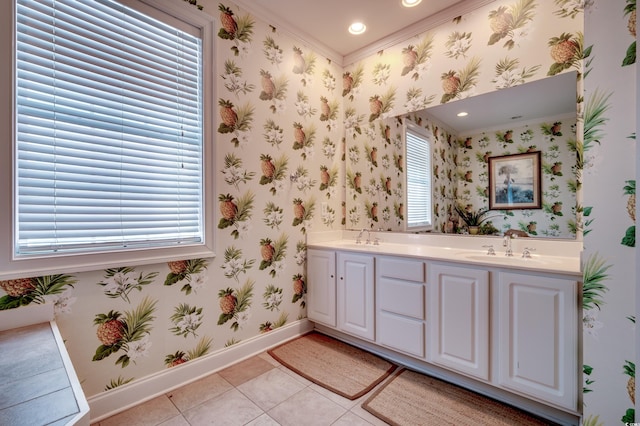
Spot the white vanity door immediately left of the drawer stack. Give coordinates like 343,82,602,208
337,252,375,340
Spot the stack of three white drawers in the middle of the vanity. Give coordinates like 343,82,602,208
376,256,426,358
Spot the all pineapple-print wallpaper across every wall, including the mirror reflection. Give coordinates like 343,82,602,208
0,0,636,426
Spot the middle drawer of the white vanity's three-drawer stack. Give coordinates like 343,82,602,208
377,277,425,320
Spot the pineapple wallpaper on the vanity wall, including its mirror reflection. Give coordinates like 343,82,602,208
343,0,588,238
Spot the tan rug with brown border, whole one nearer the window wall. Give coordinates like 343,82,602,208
267,332,396,399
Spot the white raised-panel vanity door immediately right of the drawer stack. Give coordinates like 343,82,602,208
427,263,490,380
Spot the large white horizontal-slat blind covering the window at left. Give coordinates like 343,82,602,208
14,0,204,256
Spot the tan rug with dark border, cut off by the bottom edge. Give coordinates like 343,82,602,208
362,370,552,426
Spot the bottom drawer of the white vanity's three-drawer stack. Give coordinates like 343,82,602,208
377,312,424,358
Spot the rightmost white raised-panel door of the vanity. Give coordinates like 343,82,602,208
498,272,579,410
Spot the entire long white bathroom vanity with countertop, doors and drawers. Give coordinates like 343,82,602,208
307,231,582,424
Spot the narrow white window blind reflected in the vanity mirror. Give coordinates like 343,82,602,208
405,128,432,229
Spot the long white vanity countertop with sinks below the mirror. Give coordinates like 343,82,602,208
307,231,582,277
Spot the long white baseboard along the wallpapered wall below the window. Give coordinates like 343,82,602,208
87,319,313,423
